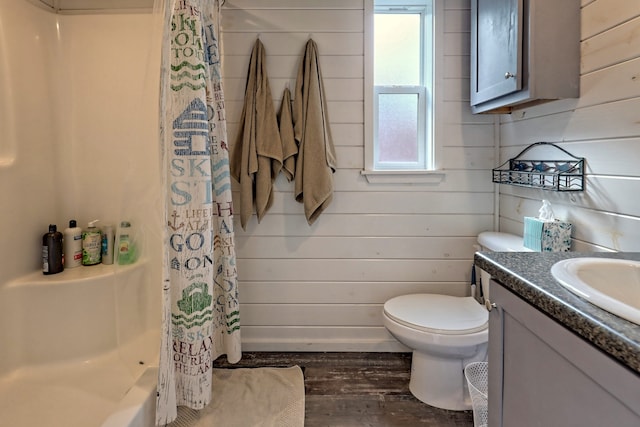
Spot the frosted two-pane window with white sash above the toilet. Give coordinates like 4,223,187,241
364,0,435,181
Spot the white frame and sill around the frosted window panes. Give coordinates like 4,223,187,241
362,0,444,183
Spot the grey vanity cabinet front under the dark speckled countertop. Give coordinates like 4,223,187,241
489,281,640,427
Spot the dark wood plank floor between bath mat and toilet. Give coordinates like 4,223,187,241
214,352,473,427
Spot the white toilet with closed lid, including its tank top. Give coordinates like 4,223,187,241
383,232,531,411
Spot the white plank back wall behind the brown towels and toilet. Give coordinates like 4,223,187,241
222,0,497,351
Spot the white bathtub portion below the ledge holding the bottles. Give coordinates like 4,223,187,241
0,261,160,427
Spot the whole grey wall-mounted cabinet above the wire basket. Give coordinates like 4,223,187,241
470,0,580,113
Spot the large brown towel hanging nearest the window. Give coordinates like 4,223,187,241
293,39,336,225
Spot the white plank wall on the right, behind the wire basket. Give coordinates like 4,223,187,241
499,0,640,251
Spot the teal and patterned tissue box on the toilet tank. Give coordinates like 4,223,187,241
524,217,572,252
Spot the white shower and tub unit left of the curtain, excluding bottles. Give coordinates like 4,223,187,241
0,0,161,427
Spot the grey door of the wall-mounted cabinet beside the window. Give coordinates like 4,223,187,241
471,0,523,105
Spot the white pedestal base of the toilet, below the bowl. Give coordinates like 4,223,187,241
409,350,486,411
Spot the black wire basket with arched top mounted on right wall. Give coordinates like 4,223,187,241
493,142,584,191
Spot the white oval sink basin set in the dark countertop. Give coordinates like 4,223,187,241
551,258,640,325
